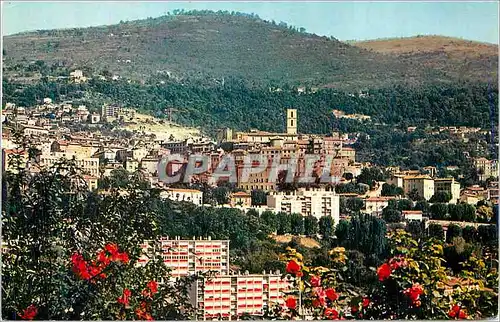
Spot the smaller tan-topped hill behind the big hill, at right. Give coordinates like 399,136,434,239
349,36,498,82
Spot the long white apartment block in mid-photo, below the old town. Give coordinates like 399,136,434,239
267,188,340,223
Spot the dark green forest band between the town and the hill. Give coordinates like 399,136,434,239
3,79,498,134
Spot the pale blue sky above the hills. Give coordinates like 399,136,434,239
2,1,499,44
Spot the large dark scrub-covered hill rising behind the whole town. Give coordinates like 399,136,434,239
4,11,498,90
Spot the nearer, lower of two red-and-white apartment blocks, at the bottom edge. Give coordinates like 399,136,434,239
190,271,292,321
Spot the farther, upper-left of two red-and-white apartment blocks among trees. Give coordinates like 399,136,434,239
139,237,229,277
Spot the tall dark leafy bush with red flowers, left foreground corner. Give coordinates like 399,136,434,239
2,155,201,320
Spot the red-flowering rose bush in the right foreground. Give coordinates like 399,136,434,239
274,230,498,320
